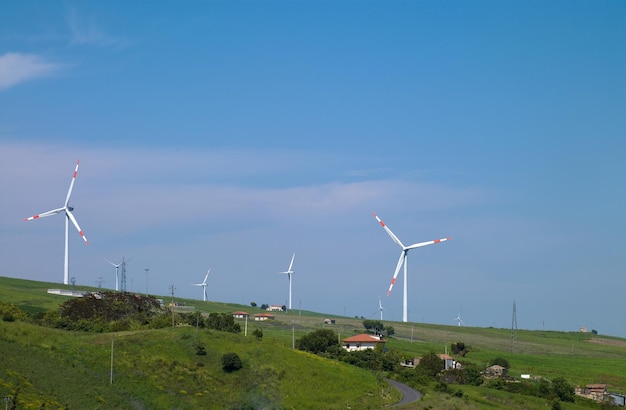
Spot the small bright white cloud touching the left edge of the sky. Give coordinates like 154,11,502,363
0,53,63,90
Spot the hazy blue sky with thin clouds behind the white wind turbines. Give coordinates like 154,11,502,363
0,1,626,337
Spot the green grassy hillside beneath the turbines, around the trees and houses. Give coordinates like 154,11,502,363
0,278,626,409
